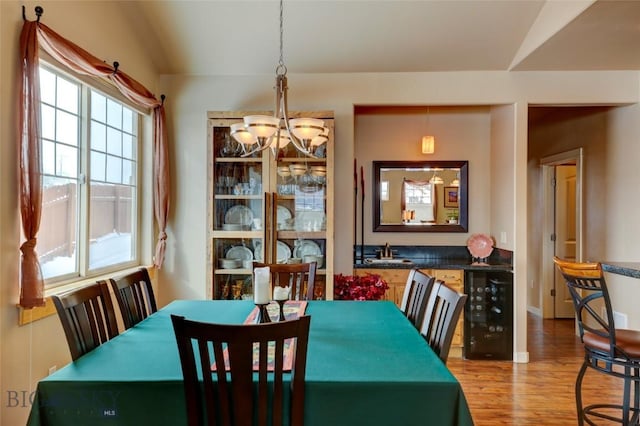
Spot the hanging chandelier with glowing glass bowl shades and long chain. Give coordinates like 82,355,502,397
231,0,329,158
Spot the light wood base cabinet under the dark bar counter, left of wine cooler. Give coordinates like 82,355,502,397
354,268,464,358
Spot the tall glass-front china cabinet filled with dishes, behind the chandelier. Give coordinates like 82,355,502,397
207,111,334,299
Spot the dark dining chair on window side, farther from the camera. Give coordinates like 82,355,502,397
109,268,158,330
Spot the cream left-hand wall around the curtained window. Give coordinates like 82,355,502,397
0,0,158,425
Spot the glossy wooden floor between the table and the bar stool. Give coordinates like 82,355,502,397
447,314,622,426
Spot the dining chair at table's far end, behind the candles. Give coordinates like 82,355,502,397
253,262,317,300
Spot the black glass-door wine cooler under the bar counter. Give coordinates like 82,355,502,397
464,271,513,360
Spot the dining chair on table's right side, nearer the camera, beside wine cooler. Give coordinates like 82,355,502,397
420,281,467,364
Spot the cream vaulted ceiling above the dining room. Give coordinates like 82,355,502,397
121,0,640,75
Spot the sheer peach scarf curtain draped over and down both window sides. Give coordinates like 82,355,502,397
18,20,169,308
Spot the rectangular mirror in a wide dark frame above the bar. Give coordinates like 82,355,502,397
373,161,469,232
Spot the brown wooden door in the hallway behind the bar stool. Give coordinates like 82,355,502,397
554,165,577,318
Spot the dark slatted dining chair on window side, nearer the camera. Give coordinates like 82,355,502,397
52,281,118,361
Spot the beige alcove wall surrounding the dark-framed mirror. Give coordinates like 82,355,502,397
352,106,491,248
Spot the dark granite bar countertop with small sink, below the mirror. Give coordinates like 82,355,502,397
353,258,513,272
